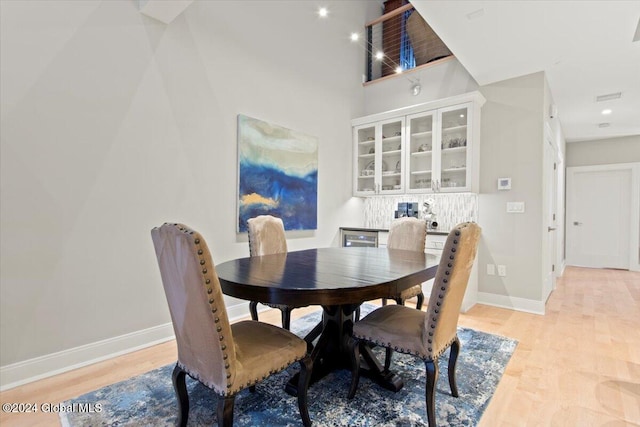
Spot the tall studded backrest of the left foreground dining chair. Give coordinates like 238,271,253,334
151,224,236,395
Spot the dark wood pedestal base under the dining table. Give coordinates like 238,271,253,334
285,304,404,396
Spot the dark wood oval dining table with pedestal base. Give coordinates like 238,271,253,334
215,247,439,394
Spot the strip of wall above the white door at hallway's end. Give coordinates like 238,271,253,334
567,135,640,166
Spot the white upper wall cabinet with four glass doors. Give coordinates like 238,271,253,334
352,92,484,196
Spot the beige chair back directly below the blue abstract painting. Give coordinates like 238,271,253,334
247,215,287,256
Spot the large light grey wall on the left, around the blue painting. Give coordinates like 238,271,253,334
0,0,379,385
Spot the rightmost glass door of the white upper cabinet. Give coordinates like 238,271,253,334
437,105,471,191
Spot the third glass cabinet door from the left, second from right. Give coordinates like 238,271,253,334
407,113,437,192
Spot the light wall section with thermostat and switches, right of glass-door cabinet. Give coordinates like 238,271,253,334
478,73,544,308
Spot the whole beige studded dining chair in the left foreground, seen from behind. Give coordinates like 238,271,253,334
151,223,312,426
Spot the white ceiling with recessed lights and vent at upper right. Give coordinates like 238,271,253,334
411,0,640,142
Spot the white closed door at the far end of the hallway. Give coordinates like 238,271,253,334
566,167,632,269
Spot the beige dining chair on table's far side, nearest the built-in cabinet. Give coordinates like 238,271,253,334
382,217,427,310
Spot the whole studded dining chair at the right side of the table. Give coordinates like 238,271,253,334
348,223,481,427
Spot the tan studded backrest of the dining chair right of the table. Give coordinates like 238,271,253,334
423,222,482,358
